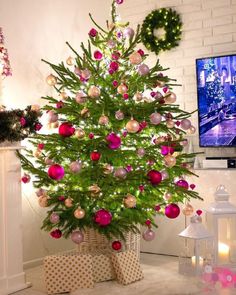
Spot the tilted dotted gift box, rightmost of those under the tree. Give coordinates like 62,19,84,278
112,250,143,285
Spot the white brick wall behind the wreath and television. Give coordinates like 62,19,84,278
119,0,236,156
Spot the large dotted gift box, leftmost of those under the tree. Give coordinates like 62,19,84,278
44,253,94,294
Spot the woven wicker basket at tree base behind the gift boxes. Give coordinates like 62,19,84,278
77,228,140,258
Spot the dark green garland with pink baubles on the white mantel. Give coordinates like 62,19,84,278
0,106,42,143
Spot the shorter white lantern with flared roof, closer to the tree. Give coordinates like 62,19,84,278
179,215,213,276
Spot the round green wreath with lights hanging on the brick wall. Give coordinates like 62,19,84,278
141,8,182,54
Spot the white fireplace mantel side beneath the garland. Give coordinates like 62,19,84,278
0,144,29,295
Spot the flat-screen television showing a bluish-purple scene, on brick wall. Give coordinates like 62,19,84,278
196,54,236,147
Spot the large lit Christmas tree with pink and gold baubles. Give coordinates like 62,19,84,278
19,0,200,243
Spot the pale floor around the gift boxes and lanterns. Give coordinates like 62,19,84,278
15,254,236,295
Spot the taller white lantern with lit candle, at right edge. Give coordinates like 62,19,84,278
206,185,236,267
